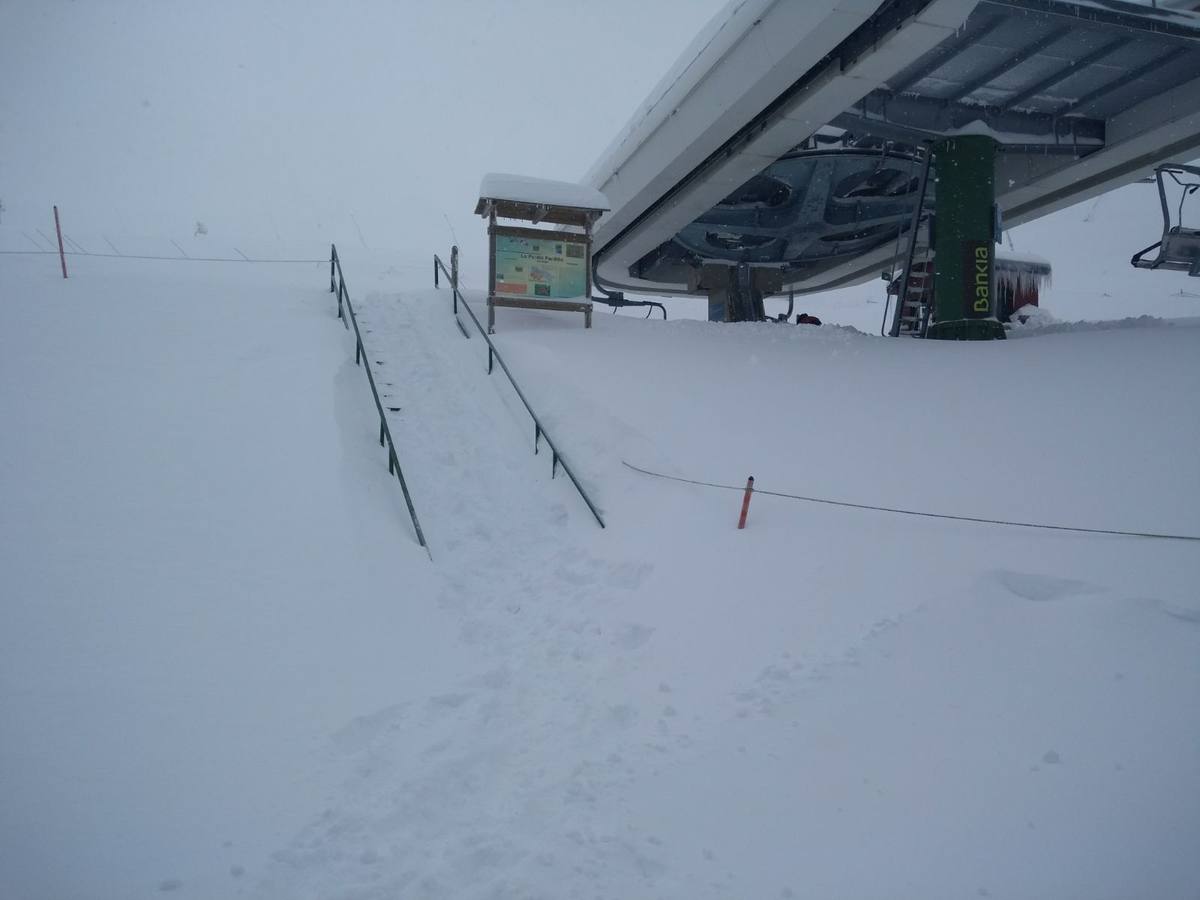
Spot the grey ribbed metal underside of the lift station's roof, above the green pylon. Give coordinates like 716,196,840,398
838,0,1200,148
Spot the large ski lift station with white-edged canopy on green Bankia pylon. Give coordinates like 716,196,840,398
504,0,1200,338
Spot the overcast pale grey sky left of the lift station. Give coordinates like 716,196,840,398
0,0,724,256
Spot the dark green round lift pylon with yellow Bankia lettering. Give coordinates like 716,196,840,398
926,134,1004,341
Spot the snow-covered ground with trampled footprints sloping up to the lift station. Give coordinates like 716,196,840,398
0,220,1200,900
